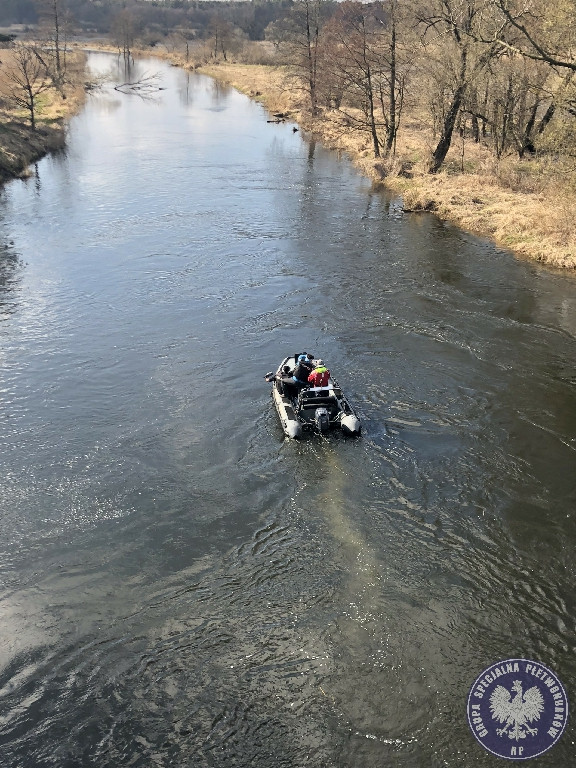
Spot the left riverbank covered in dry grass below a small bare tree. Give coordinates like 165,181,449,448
0,50,85,184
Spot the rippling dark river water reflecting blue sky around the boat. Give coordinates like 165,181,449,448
0,54,576,768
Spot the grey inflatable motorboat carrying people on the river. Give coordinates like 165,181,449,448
264,354,362,438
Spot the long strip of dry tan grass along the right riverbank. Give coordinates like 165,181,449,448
198,63,576,269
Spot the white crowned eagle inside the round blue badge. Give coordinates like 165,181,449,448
490,680,544,741
